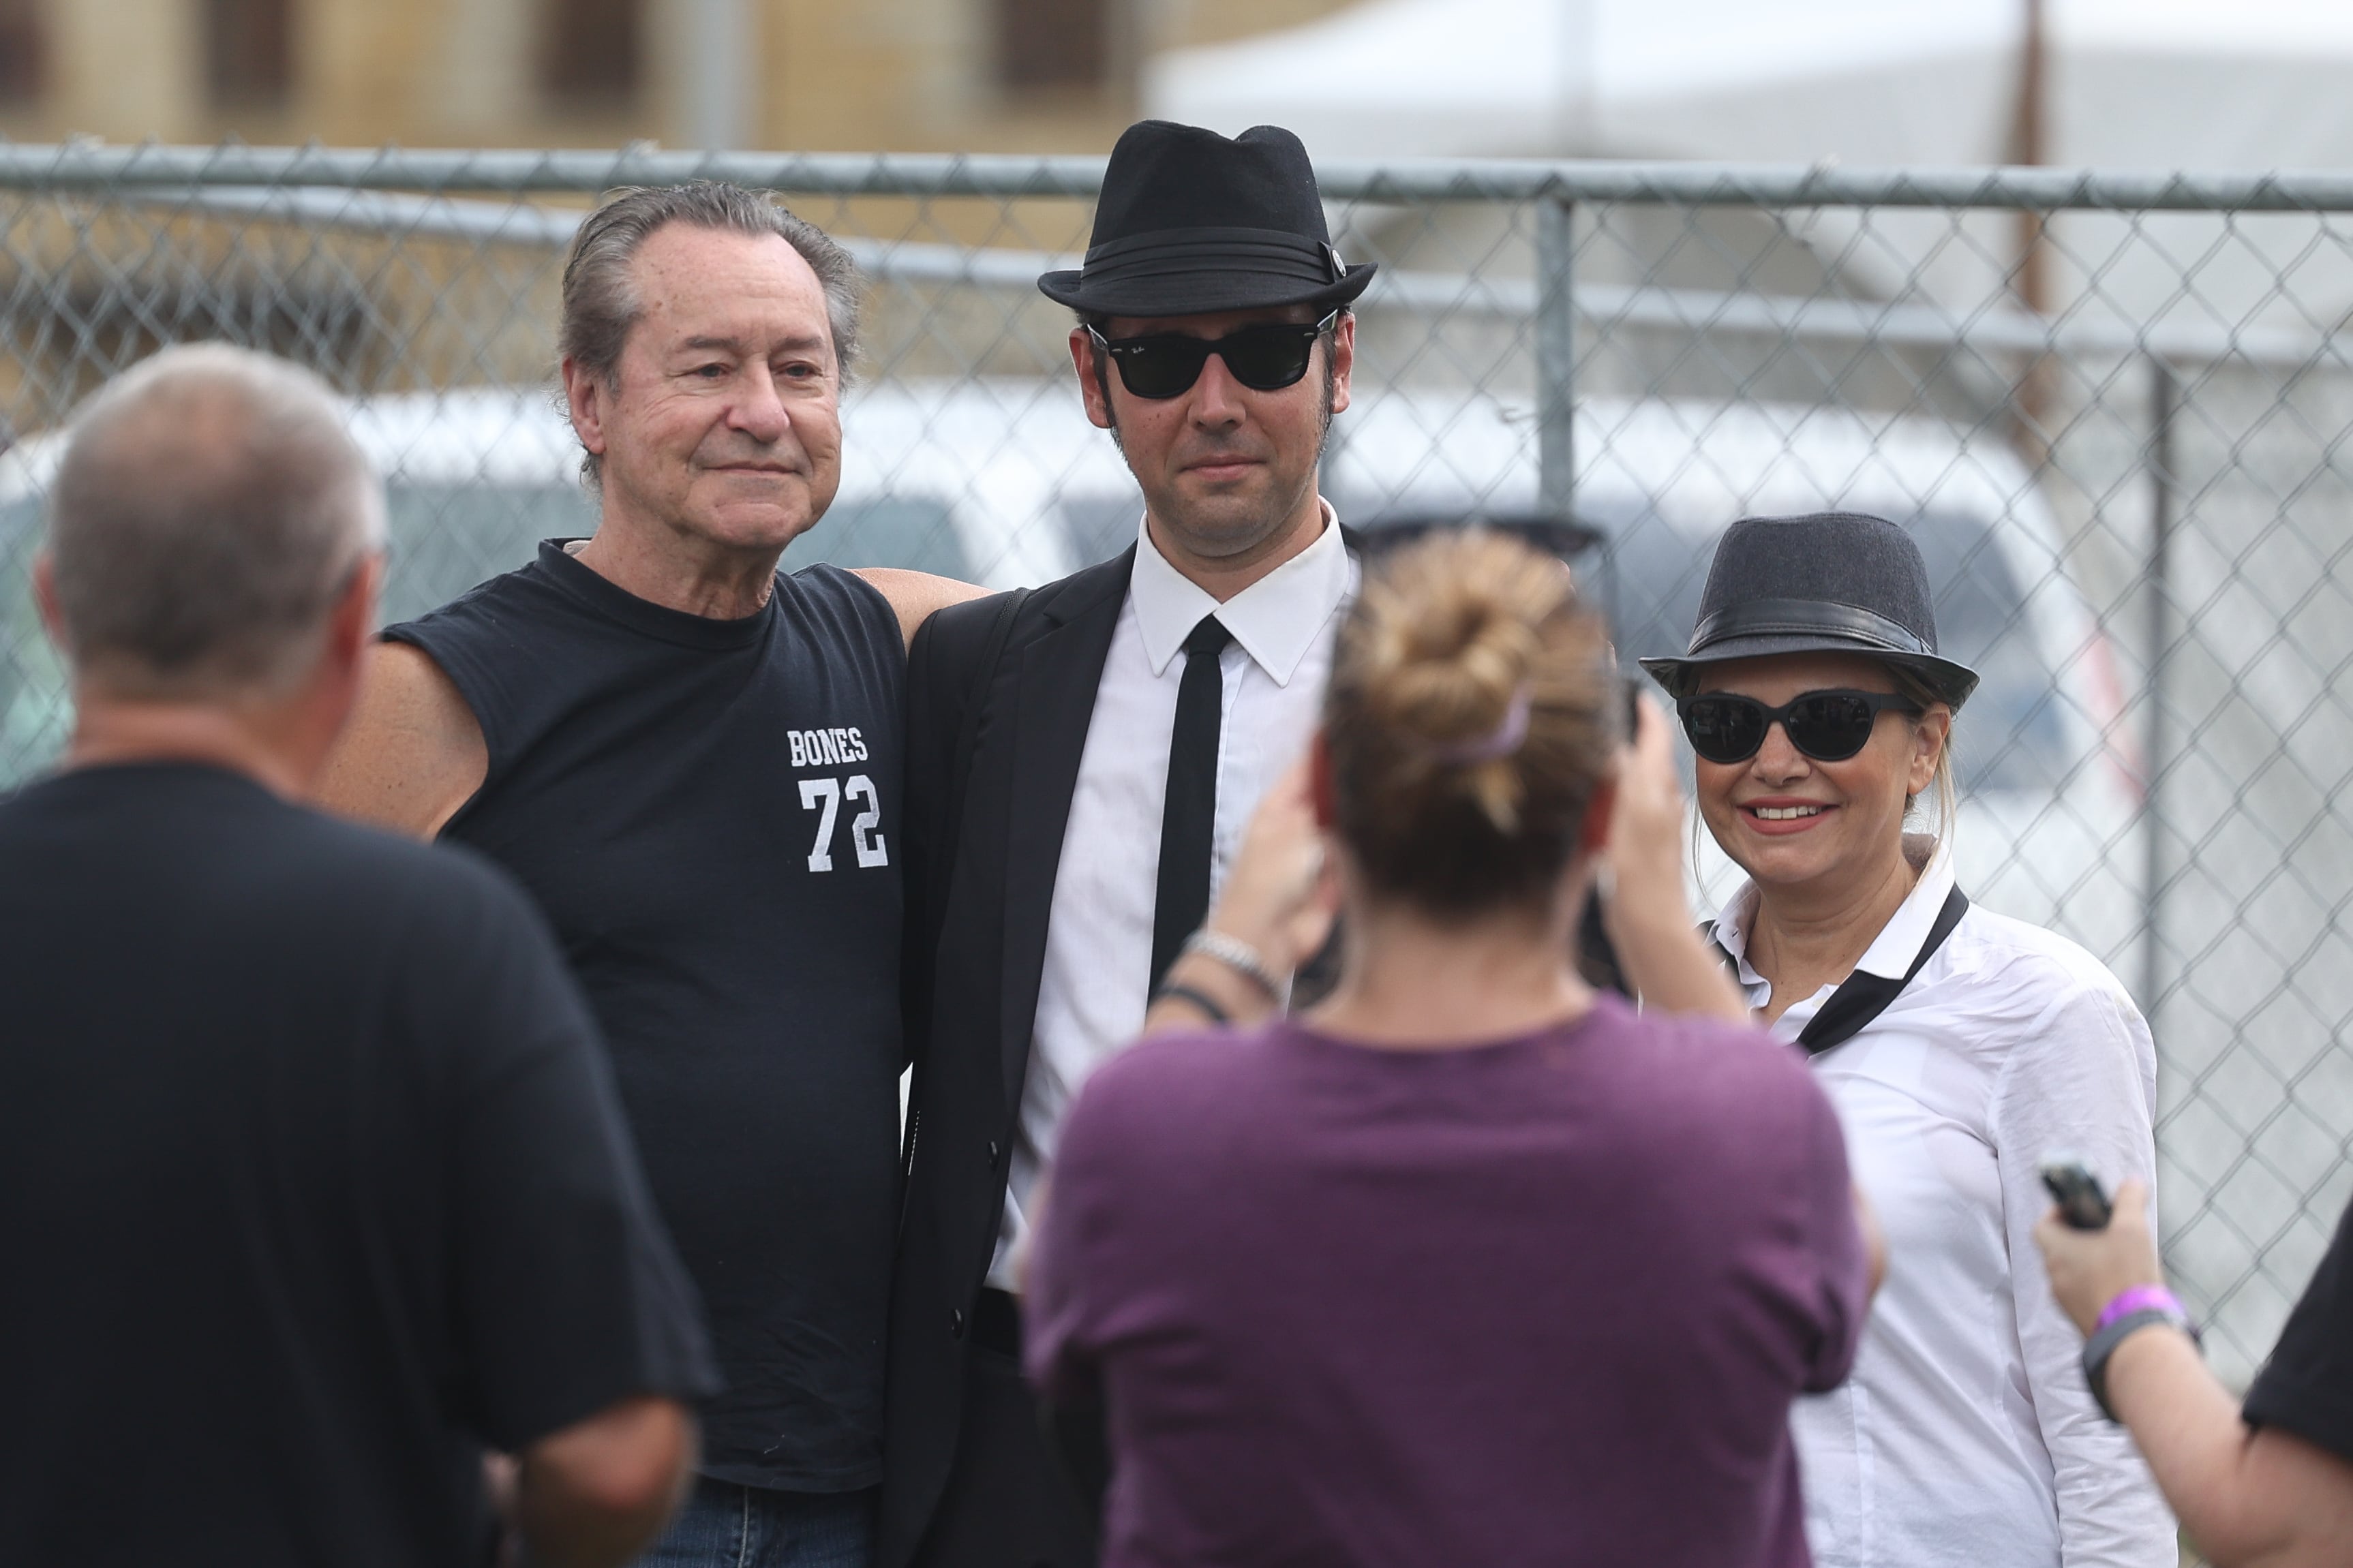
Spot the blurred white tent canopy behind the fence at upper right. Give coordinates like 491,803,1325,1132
1146,0,2353,345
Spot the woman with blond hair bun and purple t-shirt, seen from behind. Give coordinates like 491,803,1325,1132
1029,534,1873,1568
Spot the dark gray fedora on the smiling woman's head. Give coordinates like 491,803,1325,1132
1642,512,1977,707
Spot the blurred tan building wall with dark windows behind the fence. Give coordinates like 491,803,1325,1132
0,0,1348,151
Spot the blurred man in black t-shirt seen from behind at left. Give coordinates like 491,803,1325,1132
0,348,713,1568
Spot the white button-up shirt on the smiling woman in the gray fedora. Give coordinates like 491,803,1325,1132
1716,848,2179,1568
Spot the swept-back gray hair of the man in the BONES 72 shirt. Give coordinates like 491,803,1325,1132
556,179,861,487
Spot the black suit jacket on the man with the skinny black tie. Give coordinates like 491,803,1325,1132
875,548,1134,1568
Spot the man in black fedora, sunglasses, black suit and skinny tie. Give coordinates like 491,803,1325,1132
878,120,1374,1568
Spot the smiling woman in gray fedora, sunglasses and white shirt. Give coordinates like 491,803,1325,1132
1642,512,2176,1568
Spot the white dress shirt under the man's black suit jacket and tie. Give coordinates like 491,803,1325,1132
988,503,1358,1291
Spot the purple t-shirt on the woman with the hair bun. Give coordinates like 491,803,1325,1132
1024,997,1866,1568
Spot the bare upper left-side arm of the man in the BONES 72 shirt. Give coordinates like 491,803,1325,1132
311,642,489,840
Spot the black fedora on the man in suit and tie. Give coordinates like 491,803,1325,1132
1037,120,1374,315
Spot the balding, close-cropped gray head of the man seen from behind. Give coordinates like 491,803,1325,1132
49,343,384,701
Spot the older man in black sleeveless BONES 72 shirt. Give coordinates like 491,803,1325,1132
324,183,972,1568
